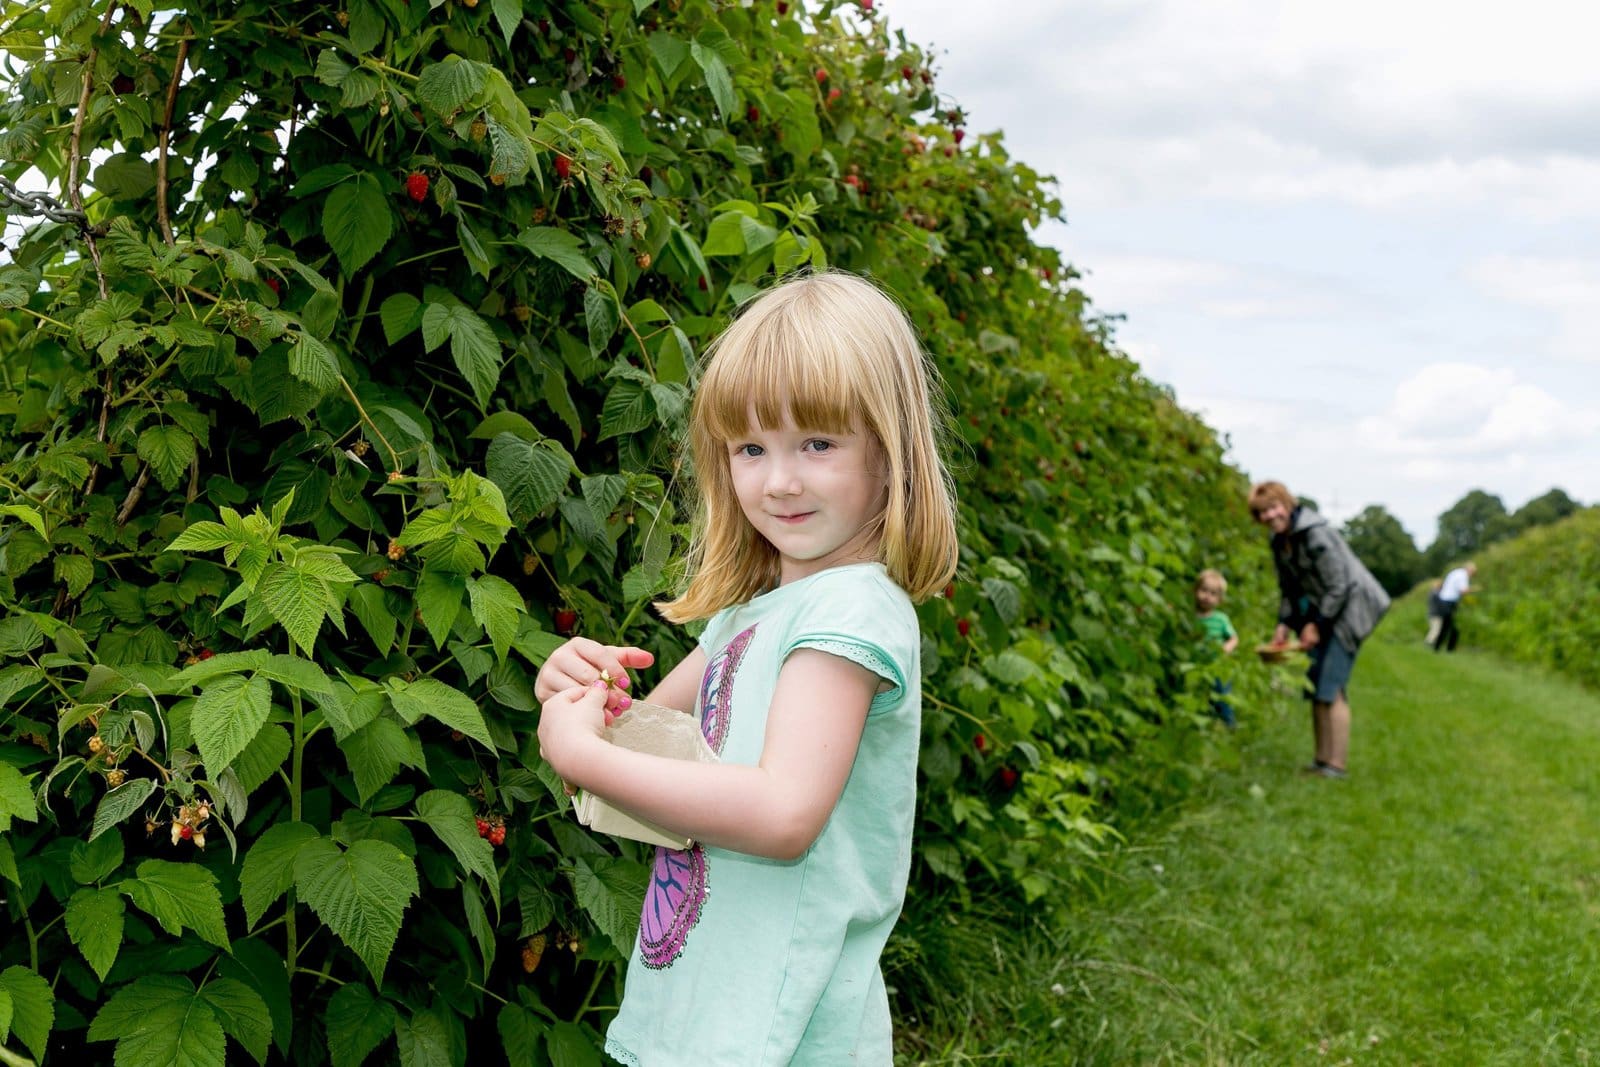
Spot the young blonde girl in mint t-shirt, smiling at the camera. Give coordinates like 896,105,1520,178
536,274,957,1067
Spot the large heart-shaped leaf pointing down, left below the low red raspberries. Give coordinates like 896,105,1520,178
294,838,418,984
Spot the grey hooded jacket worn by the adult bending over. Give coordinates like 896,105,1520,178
1272,507,1389,653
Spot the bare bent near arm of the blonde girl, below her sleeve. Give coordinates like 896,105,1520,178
539,648,882,859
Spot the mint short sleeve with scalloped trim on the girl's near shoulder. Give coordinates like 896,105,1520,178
782,568,922,712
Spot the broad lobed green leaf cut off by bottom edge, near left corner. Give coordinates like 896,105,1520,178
88,974,227,1067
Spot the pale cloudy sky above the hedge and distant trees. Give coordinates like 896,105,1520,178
877,0,1600,547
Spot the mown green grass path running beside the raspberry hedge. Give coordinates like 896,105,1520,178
902,639,1600,1067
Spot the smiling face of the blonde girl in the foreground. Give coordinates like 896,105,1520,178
728,411,888,585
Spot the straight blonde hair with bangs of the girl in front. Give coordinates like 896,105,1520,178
656,272,957,622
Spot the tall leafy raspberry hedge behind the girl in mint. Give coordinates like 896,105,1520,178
0,0,1266,1067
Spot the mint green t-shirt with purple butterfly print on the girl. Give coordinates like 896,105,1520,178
606,563,922,1067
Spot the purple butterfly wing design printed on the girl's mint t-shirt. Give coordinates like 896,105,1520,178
638,625,755,969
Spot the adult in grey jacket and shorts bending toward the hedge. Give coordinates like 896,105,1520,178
1250,482,1389,777
